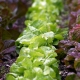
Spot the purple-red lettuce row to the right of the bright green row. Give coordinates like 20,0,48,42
56,0,80,80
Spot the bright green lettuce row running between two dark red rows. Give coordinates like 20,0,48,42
6,0,63,80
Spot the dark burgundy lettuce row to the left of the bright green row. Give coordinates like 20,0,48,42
0,0,30,78
